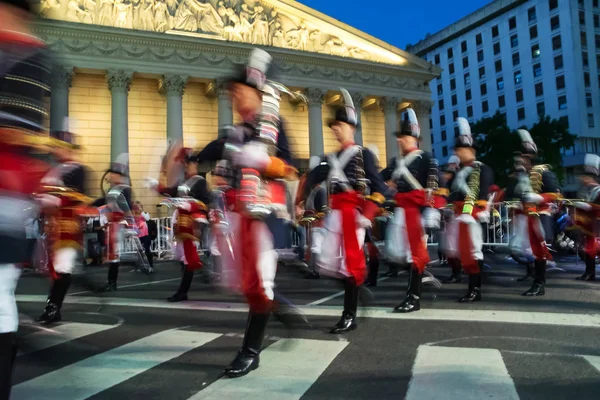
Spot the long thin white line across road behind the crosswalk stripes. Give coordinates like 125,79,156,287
16,295,600,328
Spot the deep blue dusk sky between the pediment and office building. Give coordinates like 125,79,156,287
298,0,492,49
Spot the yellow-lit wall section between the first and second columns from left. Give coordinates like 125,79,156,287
69,74,111,197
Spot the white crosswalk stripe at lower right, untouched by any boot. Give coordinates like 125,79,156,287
406,346,519,400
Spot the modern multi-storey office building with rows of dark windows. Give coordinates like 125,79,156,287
407,0,600,175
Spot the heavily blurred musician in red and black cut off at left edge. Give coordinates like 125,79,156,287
0,0,51,399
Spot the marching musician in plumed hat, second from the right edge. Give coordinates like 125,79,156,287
512,129,560,296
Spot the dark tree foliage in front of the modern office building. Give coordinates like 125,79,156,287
471,111,576,187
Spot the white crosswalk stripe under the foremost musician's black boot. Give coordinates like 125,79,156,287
189,339,348,400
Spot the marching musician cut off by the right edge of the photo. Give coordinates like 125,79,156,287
575,154,600,281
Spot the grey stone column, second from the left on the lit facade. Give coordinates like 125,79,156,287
106,69,133,162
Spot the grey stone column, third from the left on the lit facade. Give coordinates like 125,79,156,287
160,74,187,144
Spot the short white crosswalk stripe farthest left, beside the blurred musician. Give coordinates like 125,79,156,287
19,322,119,356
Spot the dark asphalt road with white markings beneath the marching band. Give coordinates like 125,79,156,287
12,256,600,400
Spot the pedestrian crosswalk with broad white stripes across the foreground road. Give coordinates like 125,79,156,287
11,322,600,400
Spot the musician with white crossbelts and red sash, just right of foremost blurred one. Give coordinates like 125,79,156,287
307,89,387,334
